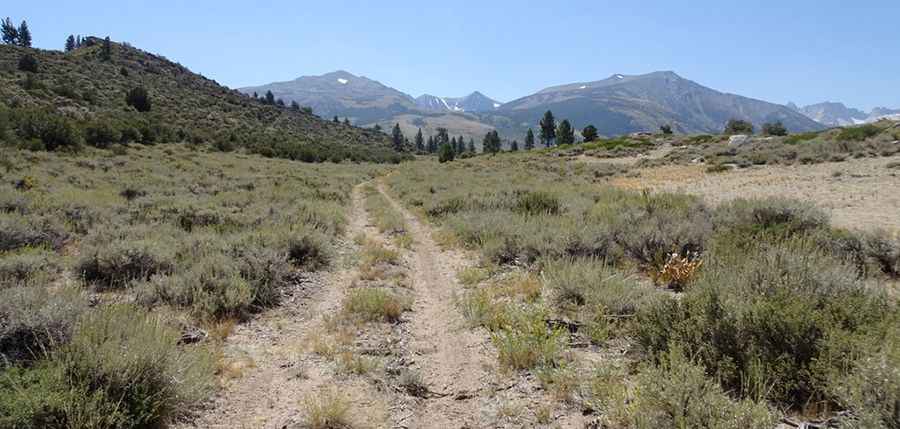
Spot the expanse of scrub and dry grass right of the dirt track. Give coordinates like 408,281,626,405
387,155,900,428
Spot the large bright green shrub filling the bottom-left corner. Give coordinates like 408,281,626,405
0,306,215,429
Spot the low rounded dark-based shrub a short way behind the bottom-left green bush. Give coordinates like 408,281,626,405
75,239,174,290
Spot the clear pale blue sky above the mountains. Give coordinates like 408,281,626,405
0,0,900,110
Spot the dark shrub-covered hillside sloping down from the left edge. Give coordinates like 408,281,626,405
0,38,398,161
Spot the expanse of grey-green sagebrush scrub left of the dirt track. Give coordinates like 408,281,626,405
0,144,379,428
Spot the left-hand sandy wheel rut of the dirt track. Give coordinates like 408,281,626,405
175,187,386,429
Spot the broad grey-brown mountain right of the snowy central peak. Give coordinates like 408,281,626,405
484,72,823,135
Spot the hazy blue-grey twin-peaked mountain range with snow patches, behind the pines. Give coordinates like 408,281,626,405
240,71,824,139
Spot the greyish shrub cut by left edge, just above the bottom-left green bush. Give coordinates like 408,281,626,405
0,287,88,362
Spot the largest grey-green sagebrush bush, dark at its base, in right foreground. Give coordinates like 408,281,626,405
637,240,893,407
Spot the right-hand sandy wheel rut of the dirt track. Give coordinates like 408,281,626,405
377,183,495,428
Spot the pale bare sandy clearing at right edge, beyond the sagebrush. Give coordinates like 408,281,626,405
612,157,900,233
